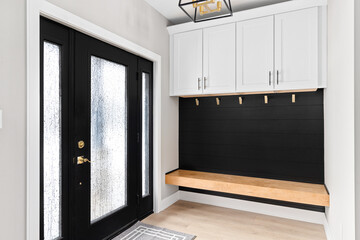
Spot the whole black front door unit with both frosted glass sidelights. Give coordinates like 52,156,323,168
41,18,153,240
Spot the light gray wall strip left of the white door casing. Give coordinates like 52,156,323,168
0,0,26,240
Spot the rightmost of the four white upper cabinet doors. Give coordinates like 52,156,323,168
275,8,319,90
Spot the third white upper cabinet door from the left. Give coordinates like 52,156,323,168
236,16,274,92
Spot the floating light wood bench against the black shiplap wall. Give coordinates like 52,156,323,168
165,170,330,206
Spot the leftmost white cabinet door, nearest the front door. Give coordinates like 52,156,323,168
173,30,203,96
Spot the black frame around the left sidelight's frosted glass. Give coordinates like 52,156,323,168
40,18,73,240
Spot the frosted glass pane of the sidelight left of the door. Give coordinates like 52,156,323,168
43,42,61,240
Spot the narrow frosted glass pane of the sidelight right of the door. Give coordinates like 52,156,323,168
141,73,150,197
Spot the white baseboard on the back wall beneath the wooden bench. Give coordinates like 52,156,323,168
179,191,327,225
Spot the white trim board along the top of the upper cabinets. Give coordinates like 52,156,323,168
168,0,327,35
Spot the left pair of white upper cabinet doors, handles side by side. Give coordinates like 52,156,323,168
173,23,236,96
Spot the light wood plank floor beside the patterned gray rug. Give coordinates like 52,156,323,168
143,201,326,240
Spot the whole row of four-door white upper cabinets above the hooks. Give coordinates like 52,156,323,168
171,7,326,96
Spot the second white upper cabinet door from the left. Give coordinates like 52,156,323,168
203,23,235,94
